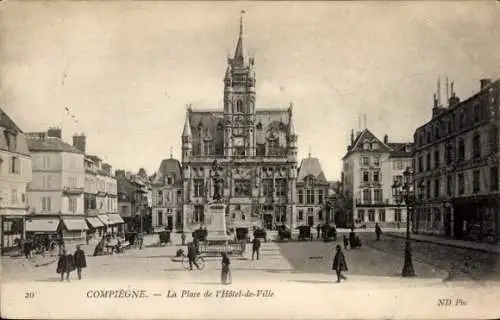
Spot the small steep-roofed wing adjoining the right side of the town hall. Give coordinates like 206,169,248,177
296,154,332,226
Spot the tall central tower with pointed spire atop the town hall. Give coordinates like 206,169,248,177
224,13,256,157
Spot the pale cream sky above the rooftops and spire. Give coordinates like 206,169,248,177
0,1,500,180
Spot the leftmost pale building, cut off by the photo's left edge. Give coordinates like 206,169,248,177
0,108,32,254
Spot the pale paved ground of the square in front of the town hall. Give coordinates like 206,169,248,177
2,233,500,285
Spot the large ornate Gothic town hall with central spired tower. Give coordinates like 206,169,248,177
182,17,297,229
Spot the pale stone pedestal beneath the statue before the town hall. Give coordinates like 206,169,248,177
205,203,229,243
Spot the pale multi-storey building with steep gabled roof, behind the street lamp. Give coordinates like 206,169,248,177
342,129,413,227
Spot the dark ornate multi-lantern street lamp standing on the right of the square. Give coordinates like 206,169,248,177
392,167,420,277
